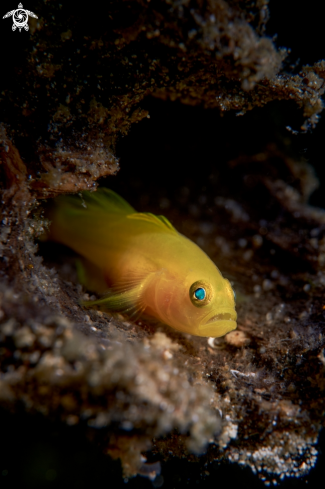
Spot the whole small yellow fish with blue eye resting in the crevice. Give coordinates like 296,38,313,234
49,188,237,337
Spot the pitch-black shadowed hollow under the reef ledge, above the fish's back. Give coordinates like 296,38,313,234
100,98,318,273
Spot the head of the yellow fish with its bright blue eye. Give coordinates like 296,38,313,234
168,268,237,337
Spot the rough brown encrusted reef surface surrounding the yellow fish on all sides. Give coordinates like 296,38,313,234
0,0,325,487
